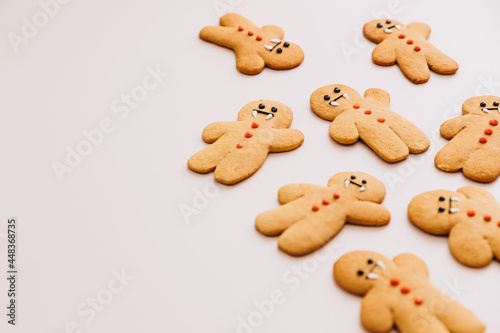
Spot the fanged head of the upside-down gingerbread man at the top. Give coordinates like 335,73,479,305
258,38,304,69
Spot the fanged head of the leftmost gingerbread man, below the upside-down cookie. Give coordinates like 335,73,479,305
238,99,293,128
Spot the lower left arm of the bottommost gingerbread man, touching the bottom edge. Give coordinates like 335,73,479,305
361,289,394,332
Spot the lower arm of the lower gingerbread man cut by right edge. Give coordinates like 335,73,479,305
449,222,493,267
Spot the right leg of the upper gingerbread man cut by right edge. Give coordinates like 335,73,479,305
462,148,500,182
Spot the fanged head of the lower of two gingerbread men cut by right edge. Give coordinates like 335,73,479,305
408,190,467,235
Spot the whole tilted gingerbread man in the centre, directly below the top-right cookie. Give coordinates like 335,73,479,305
310,84,430,162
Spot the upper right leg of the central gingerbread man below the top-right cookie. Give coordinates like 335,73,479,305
390,112,431,154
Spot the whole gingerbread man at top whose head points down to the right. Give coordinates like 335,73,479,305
200,13,304,74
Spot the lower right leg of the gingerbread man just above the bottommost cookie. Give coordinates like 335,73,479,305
278,214,344,256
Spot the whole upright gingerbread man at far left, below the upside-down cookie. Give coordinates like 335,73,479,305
188,100,304,184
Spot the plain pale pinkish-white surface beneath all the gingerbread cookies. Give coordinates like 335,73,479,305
0,0,500,333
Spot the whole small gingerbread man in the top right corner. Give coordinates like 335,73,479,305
363,19,458,83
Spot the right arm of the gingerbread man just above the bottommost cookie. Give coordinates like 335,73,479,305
346,201,391,226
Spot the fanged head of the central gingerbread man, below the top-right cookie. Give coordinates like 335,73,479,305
310,84,362,120
